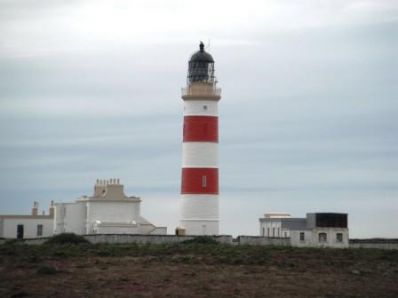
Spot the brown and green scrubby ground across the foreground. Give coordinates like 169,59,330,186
0,242,398,297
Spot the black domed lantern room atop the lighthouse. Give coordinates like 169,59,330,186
188,42,215,84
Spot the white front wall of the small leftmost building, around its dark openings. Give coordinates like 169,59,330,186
2,217,53,239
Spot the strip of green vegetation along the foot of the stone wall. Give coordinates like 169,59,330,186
0,234,398,267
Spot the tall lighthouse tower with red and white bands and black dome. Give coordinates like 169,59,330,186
180,42,221,235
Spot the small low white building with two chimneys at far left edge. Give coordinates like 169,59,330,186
0,202,54,239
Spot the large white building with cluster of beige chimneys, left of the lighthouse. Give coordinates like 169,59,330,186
54,179,167,235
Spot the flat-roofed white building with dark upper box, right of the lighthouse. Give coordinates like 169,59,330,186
259,213,349,248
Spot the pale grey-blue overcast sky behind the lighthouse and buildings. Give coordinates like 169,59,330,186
0,0,398,238
